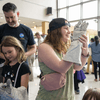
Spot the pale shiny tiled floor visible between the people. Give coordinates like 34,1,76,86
29,61,100,100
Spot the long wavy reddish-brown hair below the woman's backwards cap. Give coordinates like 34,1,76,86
44,28,67,53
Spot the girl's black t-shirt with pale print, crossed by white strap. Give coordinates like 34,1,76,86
2,62,31,88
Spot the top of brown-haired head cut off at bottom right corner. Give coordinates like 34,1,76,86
82,88,100,100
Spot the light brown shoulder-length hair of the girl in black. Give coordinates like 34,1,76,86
0,36,26,64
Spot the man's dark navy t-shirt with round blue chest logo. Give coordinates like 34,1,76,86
0,24,35,52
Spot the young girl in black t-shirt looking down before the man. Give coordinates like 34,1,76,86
0,36,30,88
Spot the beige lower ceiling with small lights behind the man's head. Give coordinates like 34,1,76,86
0,13,42,28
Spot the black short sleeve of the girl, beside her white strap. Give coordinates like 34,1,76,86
19,62,31,76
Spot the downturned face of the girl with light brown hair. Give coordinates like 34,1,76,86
2,46,17,62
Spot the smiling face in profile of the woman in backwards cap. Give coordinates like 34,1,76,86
61,23,71,43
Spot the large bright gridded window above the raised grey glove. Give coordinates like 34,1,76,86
58,0,99,36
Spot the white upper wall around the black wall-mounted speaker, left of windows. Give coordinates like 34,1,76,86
0,0,57,21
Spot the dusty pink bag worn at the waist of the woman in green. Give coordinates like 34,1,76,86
40,73,66,91
